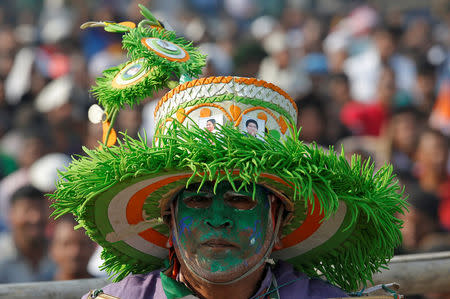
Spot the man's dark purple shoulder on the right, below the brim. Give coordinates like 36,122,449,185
273,261,348,298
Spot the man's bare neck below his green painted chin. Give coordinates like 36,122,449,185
180,266,264,299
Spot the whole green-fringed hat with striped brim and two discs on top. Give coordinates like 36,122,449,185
52,7,405,290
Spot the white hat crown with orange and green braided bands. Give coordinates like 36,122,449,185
155,76,297,137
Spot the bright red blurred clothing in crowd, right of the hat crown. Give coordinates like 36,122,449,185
340,101,388,136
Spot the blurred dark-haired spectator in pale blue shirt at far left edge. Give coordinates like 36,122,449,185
0,186,55,283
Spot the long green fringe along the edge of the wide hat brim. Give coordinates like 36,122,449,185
51,122,406,291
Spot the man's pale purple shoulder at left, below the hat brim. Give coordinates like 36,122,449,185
83,270,166,299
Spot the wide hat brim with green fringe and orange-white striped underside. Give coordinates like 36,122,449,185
51,122,405,290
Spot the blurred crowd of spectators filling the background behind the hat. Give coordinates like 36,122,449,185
0,0,450,298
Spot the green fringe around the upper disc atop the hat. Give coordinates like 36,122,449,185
122,26,206,78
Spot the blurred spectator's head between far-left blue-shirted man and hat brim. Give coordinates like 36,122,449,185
50,215,96,280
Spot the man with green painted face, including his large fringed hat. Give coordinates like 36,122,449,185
52,7,405,299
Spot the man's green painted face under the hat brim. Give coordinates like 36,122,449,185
175,182,273,280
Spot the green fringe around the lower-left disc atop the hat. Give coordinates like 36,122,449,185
91,62,169,111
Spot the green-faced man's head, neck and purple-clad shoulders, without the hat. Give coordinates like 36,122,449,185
81,182,347,299
